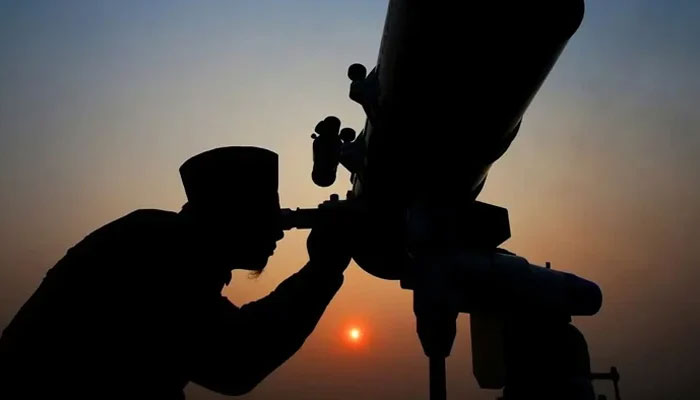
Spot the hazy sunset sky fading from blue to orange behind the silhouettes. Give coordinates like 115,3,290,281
0,0,700,400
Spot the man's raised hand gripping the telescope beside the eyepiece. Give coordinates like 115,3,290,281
306,196,354,274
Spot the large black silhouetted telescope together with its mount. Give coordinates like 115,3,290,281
282,0,616,400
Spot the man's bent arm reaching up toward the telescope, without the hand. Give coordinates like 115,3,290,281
192,262,343,395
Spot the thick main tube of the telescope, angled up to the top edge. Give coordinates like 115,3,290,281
351,0,584,279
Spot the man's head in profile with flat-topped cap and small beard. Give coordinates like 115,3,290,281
180,146,283,271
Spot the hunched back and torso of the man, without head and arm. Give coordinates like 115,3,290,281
0,210,230,397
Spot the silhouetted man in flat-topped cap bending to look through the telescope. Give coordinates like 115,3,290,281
0,147,350,399
